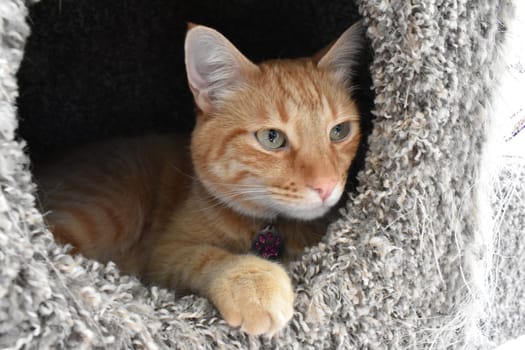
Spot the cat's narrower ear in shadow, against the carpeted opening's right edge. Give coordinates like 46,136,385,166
314,20,366,83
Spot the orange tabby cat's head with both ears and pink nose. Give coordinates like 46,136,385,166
185,22,364,220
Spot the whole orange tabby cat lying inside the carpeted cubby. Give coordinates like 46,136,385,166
36,23,363,334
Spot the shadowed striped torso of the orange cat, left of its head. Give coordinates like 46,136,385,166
34,135,192,270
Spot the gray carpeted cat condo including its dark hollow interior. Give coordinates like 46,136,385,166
0,0,525,349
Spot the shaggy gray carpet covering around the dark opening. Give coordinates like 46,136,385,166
0,0,525,349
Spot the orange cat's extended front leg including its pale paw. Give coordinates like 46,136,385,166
150,242,294,335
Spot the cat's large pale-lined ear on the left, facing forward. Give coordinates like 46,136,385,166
184,24,259,113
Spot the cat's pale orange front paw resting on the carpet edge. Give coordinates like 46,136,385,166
209,256,294,335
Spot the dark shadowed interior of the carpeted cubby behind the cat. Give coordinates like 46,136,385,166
18,0,374,188
